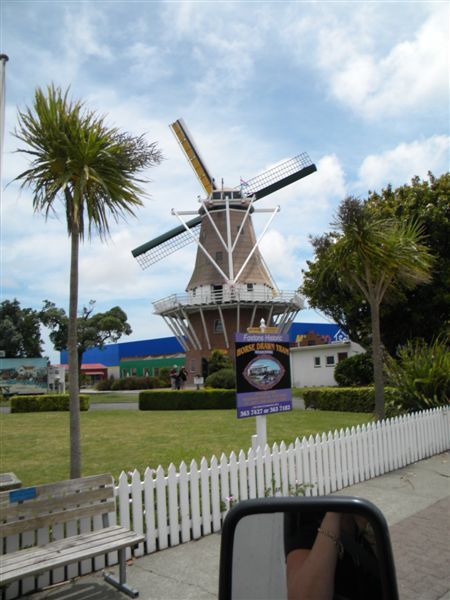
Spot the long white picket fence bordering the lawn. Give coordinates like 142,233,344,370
2,407,450,600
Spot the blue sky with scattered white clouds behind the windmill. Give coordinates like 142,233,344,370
0,0,450,362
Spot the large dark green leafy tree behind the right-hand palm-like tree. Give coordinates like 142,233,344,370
303,173,450,354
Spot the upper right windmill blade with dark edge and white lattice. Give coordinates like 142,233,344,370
241,152,317,200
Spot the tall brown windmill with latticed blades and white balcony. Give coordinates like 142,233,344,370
132,119,317,375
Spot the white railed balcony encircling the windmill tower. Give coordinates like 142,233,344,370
153,285,304,314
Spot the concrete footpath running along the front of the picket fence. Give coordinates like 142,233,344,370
29,452,450,600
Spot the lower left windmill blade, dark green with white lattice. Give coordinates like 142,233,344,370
131,217,202,269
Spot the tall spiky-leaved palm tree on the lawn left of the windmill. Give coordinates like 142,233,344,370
15,85,162,478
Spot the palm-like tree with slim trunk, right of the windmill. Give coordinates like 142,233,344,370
303,197,433,419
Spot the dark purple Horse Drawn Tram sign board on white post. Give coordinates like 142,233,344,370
235,333,292,419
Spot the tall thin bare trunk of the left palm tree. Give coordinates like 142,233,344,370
67,224,81,479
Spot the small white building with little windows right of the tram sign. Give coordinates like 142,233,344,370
291,340,365,387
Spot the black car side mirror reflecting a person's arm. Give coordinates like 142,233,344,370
219,496,398,600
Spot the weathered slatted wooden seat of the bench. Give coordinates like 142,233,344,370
0,526,145,585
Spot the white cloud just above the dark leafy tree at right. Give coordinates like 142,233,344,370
356,135,450,191
